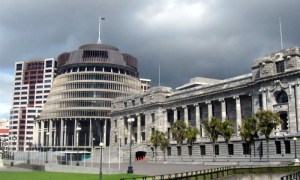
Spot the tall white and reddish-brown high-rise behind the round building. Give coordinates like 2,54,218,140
9,58,57,151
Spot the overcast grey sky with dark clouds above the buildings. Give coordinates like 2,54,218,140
0,0,300,119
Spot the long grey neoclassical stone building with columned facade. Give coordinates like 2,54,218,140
110,47,300,161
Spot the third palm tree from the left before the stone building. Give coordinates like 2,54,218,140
171,120,187,160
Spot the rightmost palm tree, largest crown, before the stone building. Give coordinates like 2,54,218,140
255,110,281,161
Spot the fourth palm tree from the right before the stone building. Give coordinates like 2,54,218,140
203,117,222,161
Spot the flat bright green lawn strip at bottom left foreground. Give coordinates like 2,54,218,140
0,171,143,180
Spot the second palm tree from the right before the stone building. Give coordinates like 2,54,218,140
239,117,258,161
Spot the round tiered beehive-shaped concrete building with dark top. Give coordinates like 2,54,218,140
35,44,142,149
